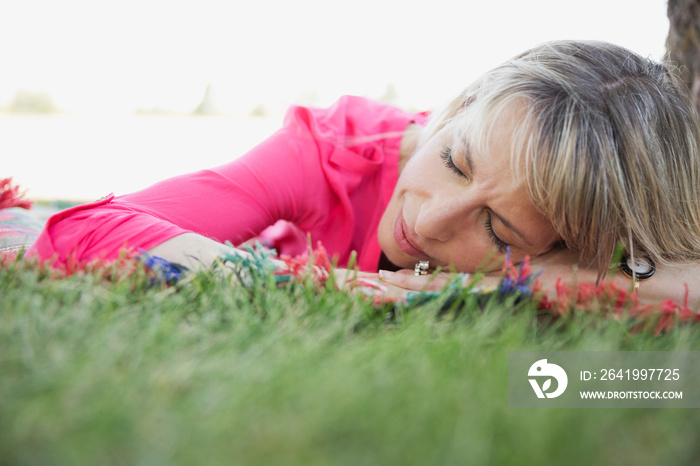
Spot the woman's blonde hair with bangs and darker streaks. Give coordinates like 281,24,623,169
424,41,700,278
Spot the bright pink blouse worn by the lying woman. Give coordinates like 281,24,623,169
28,96,427,271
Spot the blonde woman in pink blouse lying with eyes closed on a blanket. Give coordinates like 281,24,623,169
24,41,700,303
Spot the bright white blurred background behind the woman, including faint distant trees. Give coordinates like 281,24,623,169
0,0,669,201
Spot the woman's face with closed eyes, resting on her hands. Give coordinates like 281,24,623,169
379,102,560,272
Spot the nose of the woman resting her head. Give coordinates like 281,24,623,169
415,195,479,241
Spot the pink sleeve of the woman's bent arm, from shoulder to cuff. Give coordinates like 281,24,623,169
28,108,327,264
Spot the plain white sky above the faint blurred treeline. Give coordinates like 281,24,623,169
0,0,668,115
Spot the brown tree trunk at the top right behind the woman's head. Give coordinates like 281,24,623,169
666,0,700,113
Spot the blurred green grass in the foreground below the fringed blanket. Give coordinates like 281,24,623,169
0,264,700,465
